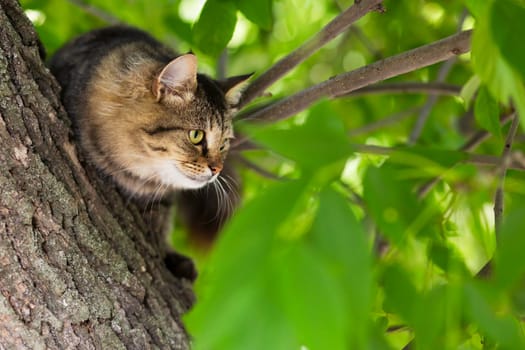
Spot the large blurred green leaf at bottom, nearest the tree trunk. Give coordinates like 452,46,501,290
185,181,308,350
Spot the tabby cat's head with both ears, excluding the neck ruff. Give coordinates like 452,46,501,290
126,54,249,189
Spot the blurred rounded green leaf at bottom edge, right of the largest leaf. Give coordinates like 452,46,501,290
275,244,348,350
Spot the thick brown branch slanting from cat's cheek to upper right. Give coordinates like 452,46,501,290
246,31,472,121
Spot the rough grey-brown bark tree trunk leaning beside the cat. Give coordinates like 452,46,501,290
0,0,193,349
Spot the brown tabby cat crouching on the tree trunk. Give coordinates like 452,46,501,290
49,26,251,278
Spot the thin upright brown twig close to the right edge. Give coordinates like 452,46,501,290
494,113,520,234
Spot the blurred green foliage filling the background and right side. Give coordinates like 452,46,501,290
22,0,525,350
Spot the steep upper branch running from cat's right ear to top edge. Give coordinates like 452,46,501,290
239,0,382,107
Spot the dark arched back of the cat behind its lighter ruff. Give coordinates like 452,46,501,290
49,26,175,112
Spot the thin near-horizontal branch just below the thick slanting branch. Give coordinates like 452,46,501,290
342,82,461,97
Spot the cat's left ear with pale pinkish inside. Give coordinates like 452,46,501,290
153,54,197,102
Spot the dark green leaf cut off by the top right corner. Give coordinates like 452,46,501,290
490,0,525,79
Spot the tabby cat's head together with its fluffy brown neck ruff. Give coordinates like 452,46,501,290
80,50,249,196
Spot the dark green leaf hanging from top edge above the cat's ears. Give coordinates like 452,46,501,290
193,0,237,57
